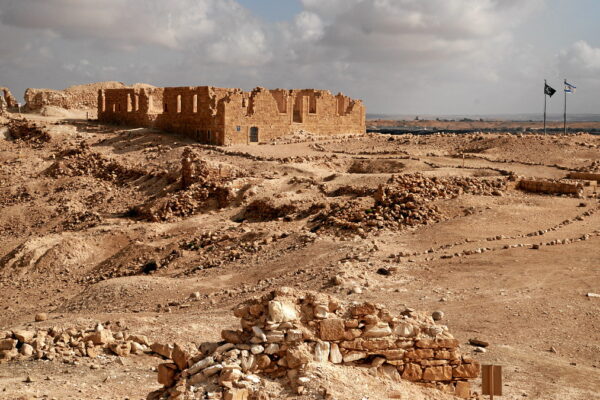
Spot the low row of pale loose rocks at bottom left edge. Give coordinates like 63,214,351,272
0,322,157,362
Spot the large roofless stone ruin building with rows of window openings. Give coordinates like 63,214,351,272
98,86,365,145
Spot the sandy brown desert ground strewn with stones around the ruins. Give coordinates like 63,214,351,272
0,114,600,400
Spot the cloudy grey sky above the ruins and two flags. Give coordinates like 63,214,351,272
0,0,600,115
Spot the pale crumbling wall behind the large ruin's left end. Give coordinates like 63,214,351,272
25,81,125,112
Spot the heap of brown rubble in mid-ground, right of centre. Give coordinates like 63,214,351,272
314,174,506,234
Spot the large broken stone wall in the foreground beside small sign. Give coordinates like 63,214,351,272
148,288,480,400
